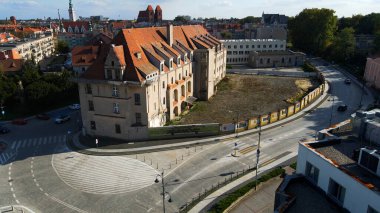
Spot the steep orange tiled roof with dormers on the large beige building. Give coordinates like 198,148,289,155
82,25,217,82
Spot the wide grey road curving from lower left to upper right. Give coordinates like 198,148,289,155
0,62,372,212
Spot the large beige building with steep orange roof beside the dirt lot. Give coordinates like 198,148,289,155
73,25,226,141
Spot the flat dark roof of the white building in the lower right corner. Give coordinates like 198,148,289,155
303,136,380,191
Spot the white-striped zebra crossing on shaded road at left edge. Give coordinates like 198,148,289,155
0,135,66,165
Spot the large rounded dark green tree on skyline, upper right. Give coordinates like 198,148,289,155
288,8,338,54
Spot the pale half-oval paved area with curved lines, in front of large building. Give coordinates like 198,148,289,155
52,150,158,194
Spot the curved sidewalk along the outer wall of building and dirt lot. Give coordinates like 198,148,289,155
68,83,329,155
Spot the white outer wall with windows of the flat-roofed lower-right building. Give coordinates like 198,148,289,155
297,144,380,212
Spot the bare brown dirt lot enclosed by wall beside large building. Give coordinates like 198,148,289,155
173,74,319,124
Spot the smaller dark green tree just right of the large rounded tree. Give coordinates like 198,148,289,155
331,27,355,62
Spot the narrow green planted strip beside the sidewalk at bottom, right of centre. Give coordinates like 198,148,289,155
207,168,285,213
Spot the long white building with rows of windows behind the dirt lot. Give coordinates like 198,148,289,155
221,39,286,64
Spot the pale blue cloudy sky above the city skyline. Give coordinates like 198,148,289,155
0,0,380,19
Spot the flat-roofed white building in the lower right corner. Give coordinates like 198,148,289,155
297,139,380,213
